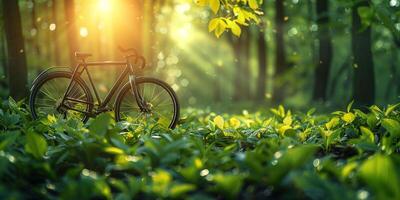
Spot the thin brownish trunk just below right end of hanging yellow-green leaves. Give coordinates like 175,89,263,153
256,31,267,101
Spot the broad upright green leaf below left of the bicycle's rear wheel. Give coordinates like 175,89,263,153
25,130,47,159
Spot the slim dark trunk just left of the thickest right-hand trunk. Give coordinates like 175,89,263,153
313,0,332,101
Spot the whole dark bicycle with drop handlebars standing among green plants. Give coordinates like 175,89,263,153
29,47,179,129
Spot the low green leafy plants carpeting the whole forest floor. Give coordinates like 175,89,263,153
0,100,400,199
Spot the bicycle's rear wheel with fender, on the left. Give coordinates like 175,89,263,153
29,71,93,122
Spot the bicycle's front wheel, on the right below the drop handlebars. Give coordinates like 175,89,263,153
115,78,179,129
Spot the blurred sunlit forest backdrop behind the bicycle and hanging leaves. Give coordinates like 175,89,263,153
0,0,400,111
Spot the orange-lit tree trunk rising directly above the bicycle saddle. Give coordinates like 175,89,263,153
64,0,79,67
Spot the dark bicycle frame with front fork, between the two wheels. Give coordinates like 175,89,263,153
57,58,146,117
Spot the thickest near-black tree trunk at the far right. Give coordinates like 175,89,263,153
351,0,375,106
